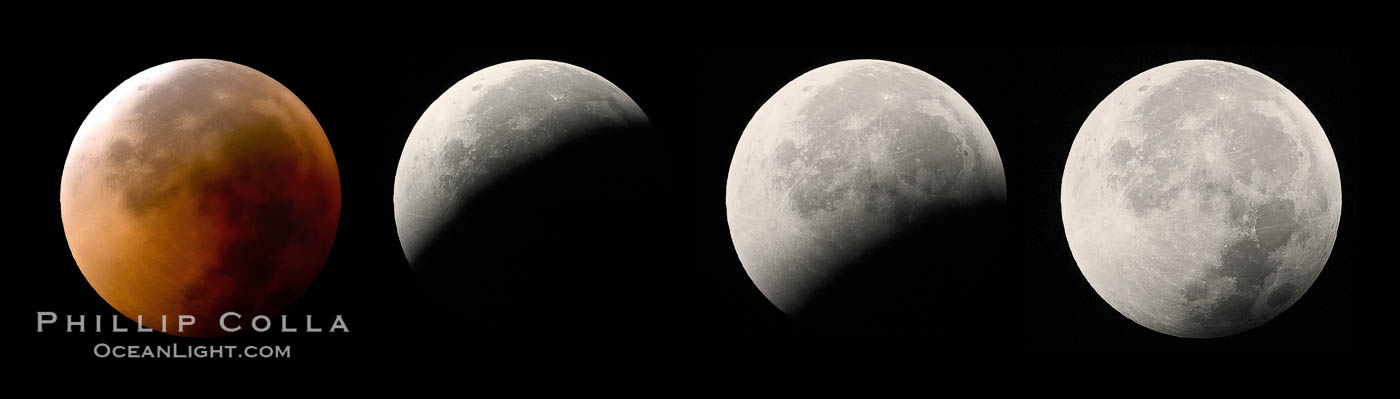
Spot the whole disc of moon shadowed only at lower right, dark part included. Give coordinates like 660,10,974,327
725,60,1007,329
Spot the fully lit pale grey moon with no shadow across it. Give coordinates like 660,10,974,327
1060,60,1341,337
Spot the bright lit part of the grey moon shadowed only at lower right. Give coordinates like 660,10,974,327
725,60,1007,318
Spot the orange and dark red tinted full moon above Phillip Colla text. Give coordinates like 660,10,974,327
59,59,340,336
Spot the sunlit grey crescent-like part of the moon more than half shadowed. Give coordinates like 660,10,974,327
393,60,650,284
